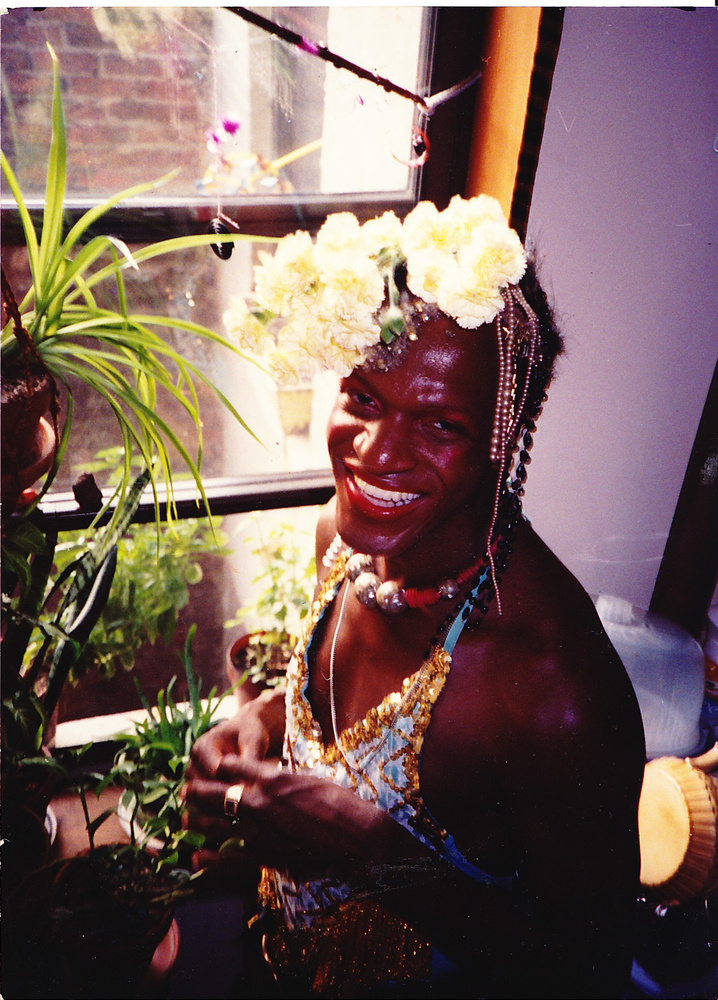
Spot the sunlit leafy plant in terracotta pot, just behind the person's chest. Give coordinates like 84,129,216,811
226,518,315,702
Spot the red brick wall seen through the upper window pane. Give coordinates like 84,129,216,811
0,7,213,196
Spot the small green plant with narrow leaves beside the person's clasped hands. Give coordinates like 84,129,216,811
109,625,233,864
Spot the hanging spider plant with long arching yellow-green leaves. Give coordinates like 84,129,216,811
1,45,273,532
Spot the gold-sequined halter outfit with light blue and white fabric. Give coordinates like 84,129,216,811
260,554,512,996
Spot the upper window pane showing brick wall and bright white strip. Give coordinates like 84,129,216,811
2,7,428,202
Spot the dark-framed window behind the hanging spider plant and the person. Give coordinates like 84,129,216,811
2,7,448,719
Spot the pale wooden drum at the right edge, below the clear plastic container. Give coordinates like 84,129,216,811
638,743,718,906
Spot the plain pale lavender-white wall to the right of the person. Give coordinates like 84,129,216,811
525,8,718,608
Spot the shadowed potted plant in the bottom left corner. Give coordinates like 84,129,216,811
3,748,198,998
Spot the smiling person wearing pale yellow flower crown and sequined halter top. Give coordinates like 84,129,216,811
187,196,644,998
